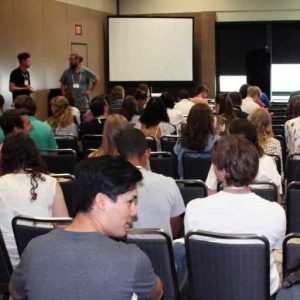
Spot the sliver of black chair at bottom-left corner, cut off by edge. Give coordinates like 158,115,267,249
0,231,13,300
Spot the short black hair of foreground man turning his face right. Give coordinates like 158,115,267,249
73,155,143,213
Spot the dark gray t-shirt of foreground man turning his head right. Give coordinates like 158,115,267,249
12,230,157,300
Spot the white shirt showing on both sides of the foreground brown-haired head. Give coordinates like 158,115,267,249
205,155,282,194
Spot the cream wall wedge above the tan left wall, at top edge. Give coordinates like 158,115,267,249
56,0,117,14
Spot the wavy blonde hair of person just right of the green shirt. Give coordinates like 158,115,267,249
47,96,74,128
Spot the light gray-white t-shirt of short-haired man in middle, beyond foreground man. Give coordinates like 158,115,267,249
133,168,185,237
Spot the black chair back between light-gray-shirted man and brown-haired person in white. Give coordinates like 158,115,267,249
176,179,207,206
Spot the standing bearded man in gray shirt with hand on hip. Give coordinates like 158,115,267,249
60,53,99,108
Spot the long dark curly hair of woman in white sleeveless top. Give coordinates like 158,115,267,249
1,132,48,201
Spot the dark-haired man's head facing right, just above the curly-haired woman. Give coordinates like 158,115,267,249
0,109,33,135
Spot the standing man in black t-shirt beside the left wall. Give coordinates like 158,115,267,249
9,52,34,101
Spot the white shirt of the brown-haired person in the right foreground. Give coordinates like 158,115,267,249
184,191,286,294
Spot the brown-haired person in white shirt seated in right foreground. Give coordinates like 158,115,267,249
184,135,286,294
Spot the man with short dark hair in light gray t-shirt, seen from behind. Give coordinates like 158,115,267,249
116,128,185,237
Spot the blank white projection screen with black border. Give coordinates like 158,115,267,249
108,17,194,82
